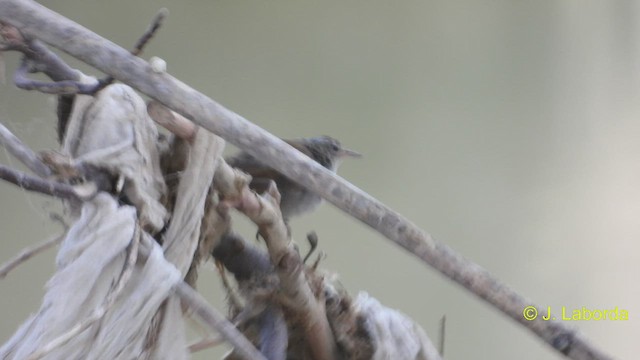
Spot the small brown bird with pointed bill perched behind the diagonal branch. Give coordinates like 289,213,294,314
227,136,362,220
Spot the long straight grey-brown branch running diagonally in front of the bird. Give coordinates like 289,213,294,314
0,0,610,359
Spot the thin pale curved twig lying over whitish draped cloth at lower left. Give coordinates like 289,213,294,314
27,225,141,360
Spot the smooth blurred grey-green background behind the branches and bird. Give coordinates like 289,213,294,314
0,0,640,359
